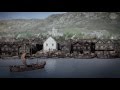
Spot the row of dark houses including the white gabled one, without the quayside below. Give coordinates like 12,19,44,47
0,37,120,58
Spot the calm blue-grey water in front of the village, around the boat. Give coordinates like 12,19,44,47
0,58,120,78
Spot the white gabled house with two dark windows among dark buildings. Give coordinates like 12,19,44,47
43,37,57,52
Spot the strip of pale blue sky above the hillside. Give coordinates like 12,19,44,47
0,12,65,20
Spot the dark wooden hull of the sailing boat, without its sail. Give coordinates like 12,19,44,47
9,62,46,72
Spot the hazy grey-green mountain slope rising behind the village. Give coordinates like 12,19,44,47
0,12,120,38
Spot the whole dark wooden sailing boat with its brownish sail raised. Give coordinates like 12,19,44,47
9,53,46,72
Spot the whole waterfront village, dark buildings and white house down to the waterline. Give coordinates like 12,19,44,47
0,27,120,59
